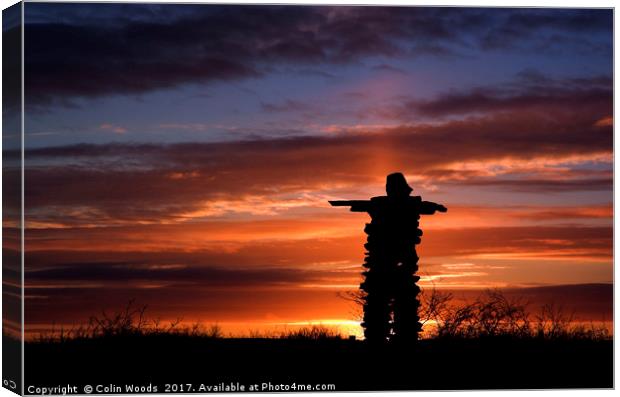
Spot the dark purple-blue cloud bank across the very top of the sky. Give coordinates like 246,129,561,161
25,4,612,105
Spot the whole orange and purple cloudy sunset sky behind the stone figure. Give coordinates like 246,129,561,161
4,3,613,338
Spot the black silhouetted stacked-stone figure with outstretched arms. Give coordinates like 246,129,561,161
329,172,447,343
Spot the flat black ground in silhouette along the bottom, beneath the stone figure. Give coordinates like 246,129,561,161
26,335,613,392
